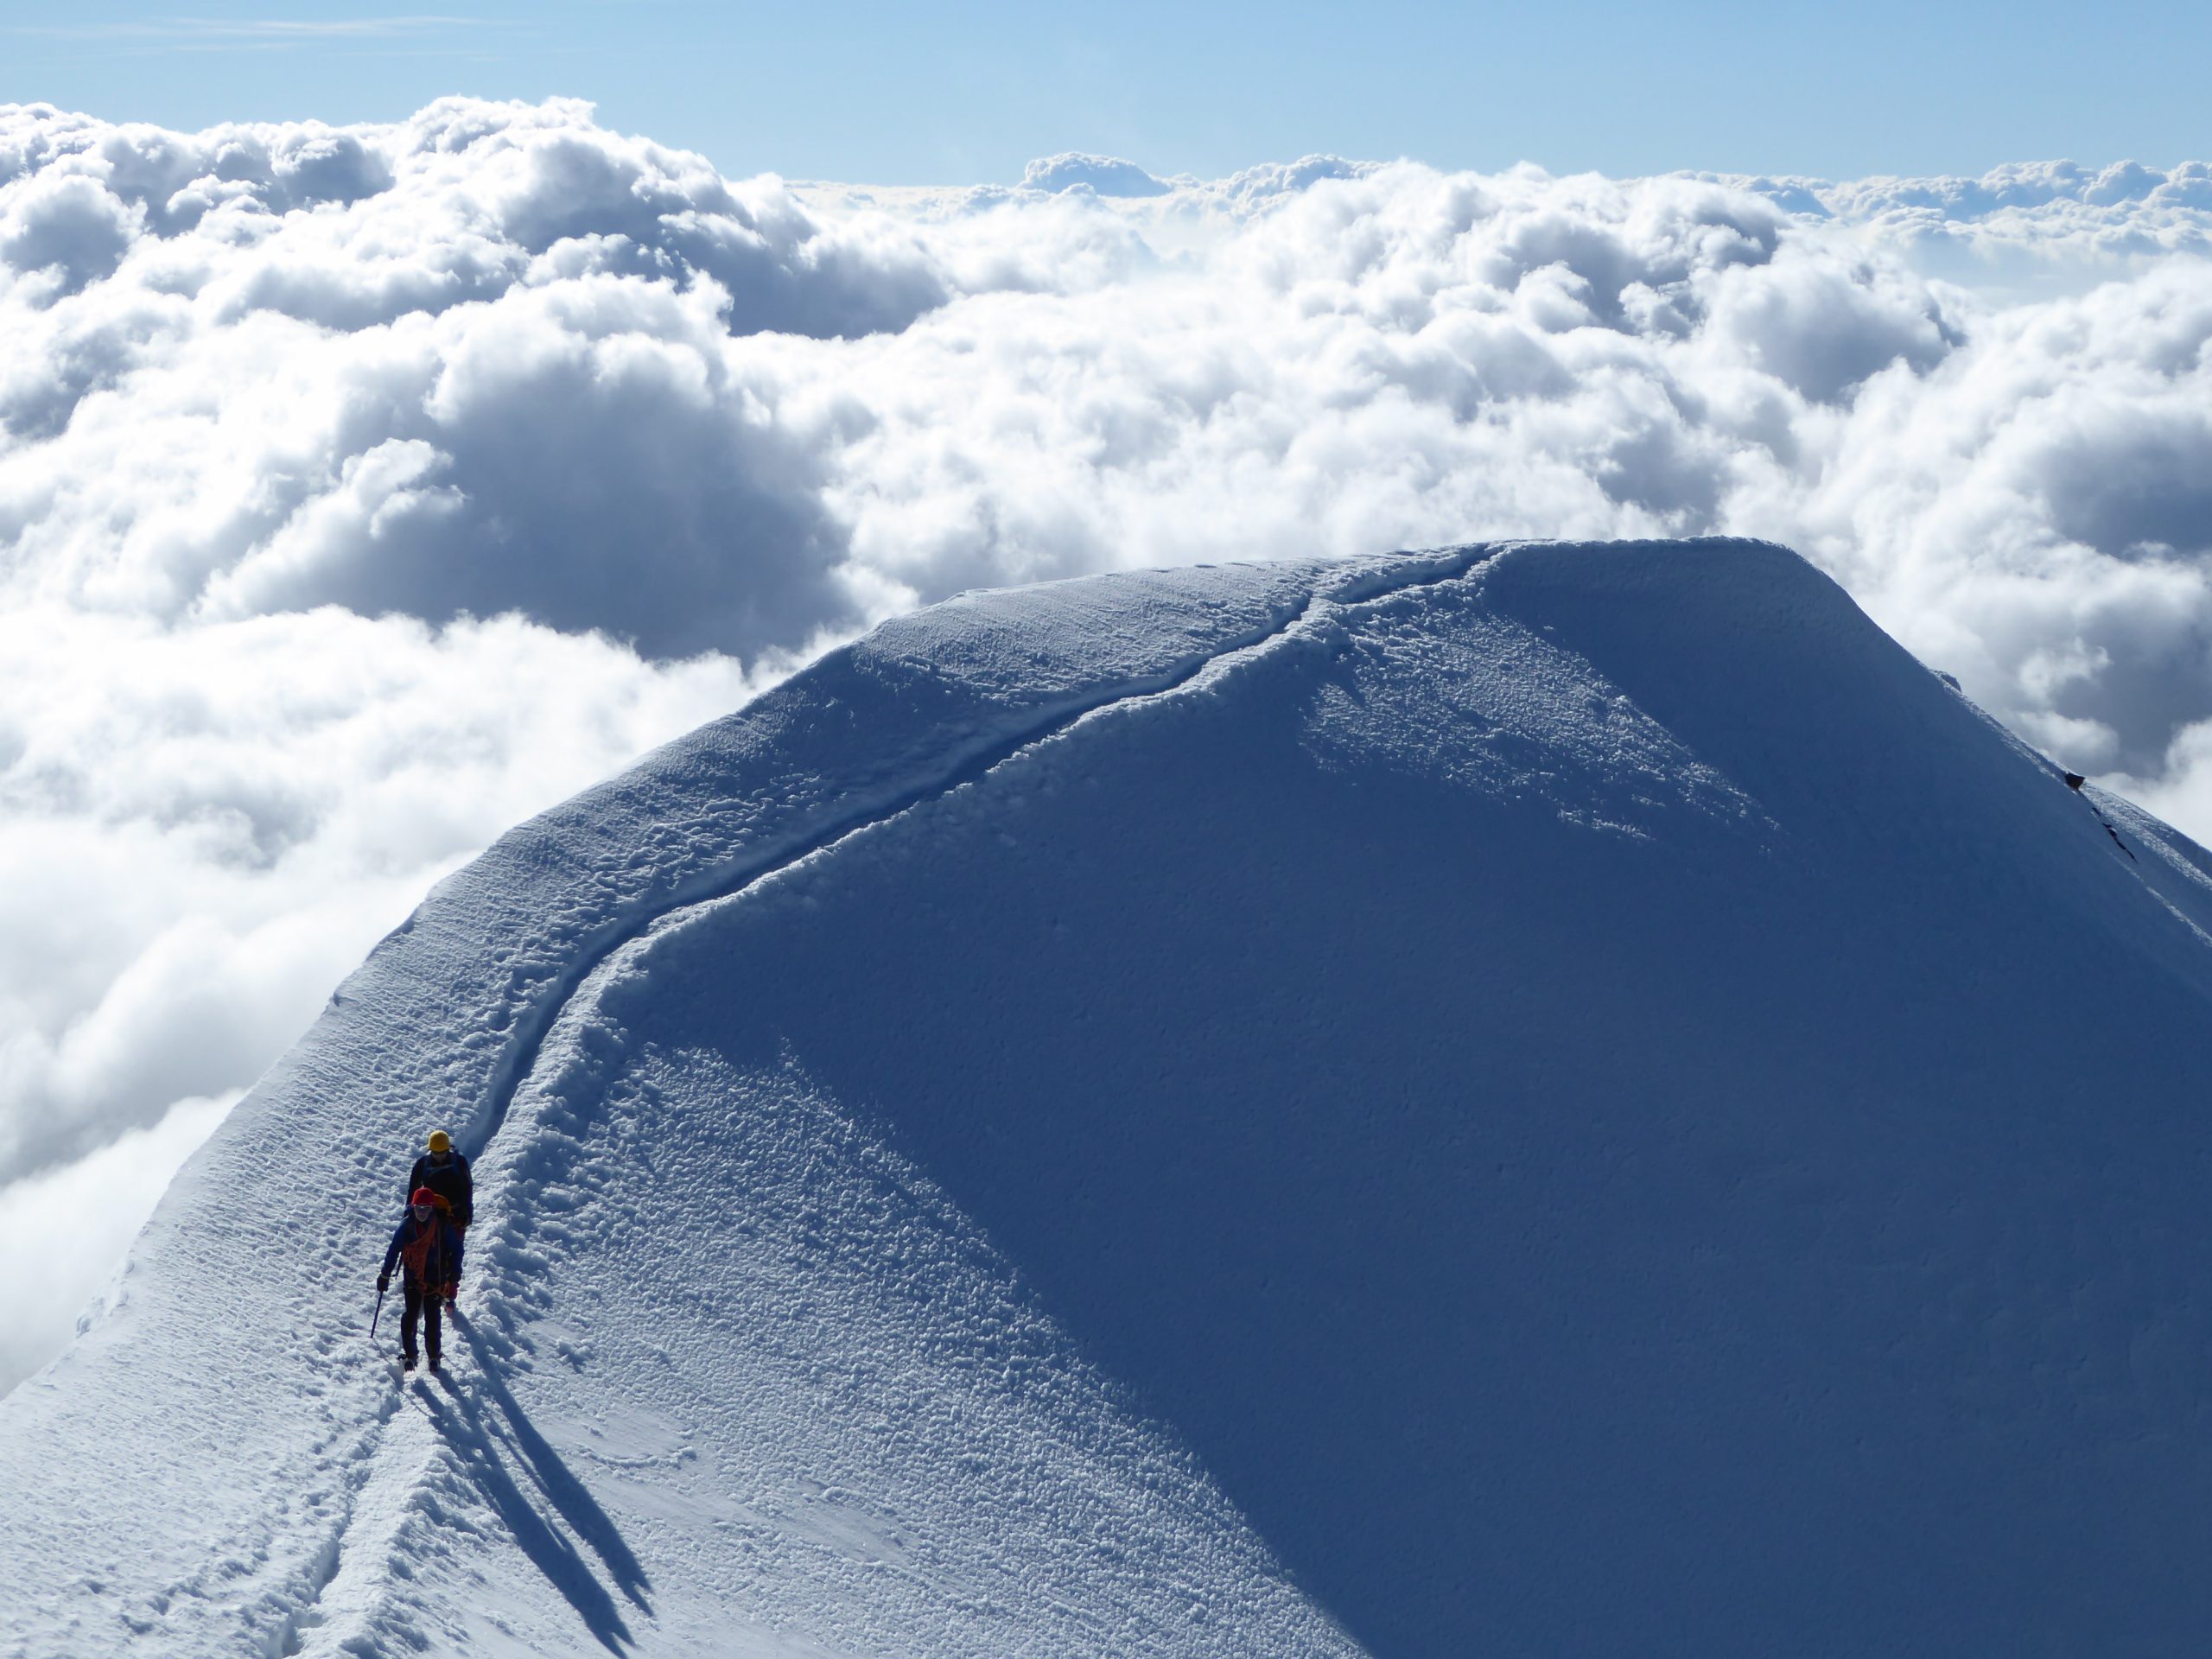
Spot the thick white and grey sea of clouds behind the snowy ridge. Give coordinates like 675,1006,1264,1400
0,99,2212,1387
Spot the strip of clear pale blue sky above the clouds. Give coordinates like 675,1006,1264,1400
0,0,2212,183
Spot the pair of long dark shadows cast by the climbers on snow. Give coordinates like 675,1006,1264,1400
427,1316,652,1652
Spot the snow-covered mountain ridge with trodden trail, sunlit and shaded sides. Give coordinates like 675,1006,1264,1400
0,542,2212,1655
